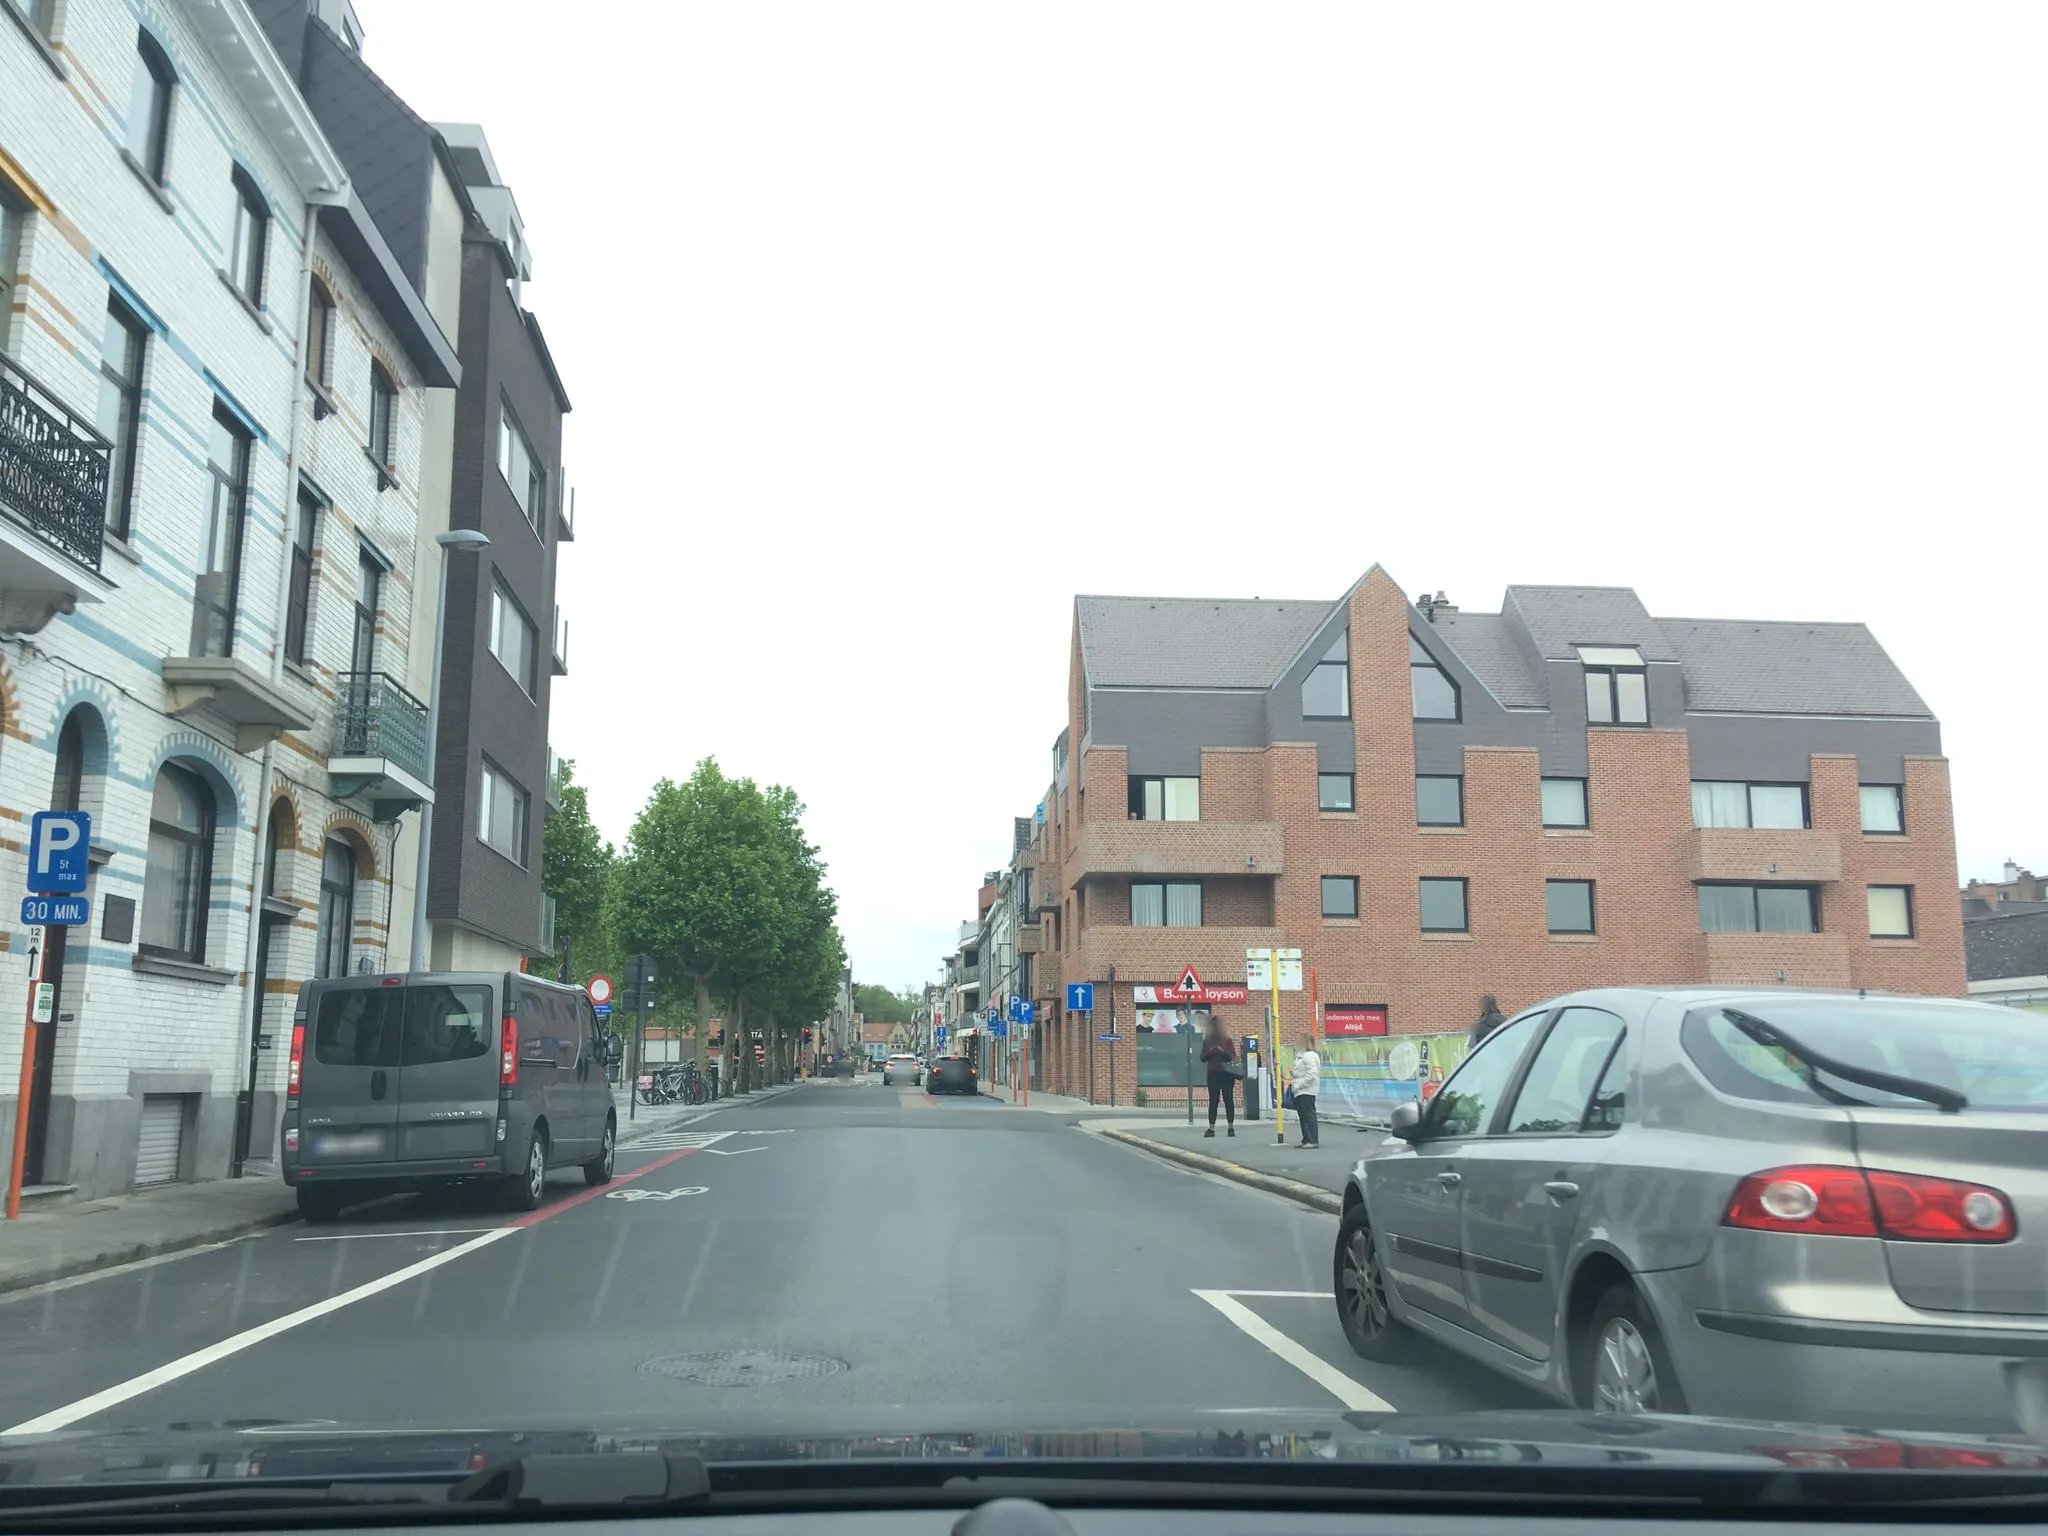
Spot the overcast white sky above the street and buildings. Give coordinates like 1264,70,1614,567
356,0,2048,999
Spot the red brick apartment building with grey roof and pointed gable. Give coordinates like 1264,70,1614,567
1020,567,1964,1100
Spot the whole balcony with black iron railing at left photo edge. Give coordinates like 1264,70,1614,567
0,354,113,635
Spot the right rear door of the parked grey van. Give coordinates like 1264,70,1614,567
397,977,498,1161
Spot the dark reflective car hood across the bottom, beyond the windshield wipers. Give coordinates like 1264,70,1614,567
0,1409,2048,1487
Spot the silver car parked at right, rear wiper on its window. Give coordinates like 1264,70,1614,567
1335,987,2048,1430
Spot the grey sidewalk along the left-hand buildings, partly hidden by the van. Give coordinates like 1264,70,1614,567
0,1083,799,1294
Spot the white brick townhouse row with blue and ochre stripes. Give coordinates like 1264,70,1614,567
0,0,457,1194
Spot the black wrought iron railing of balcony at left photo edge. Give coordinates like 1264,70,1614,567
0,354,113,569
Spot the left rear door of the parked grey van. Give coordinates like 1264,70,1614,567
299,981,403,1167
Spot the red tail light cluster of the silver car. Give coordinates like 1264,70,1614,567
1722,1165,2019,1243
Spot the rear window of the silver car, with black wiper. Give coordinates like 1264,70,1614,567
1679,997,2048,1112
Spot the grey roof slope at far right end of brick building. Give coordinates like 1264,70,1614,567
1657,618,1933,719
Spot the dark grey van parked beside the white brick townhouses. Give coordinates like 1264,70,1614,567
281,971,618,1221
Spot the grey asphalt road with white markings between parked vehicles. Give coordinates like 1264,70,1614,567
0,1079,1536,1434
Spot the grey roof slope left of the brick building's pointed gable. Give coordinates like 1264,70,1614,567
1073,596,1337,688
